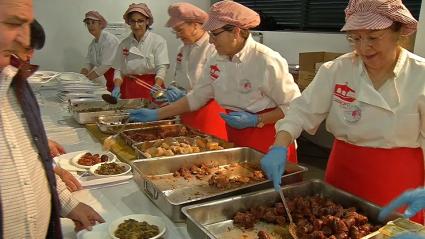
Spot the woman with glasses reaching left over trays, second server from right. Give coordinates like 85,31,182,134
130,1,300,161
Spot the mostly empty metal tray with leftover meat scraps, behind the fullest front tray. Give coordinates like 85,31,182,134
132,148,307,222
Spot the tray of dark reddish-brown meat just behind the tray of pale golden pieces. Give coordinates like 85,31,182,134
120,124,204,146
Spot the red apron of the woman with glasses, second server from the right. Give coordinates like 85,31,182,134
226,109,298,163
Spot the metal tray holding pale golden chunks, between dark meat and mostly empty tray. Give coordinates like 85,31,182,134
132,133,234,159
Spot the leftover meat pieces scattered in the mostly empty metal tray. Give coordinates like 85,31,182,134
173,163,266,189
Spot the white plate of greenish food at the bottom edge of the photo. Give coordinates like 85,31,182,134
108,214,166,239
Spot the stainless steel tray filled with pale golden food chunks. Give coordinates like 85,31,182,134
132,133,234,159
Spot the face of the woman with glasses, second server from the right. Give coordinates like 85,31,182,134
208,28,237,56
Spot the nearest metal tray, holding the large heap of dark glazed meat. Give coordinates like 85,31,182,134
182,180,400,239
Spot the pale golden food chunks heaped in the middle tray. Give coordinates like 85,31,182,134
137,136,224,158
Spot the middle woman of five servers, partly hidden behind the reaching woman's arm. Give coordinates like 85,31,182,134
166,2,227,140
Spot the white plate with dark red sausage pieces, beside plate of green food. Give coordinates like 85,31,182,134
71,151,117,169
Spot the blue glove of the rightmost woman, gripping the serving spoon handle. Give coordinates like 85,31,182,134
261,146,288,192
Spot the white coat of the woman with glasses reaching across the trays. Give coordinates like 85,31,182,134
187,35,300,113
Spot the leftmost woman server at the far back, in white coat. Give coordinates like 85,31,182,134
80,11,119,92
